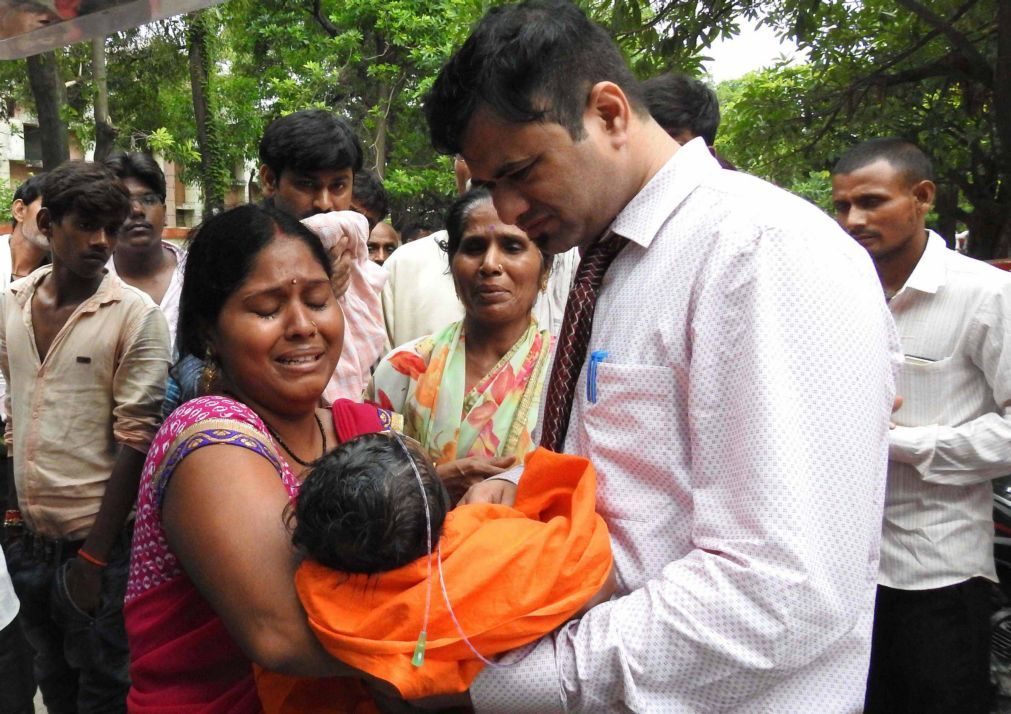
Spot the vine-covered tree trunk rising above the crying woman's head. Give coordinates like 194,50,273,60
186,11,224,211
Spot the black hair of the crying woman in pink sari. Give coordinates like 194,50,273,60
177,204,332,358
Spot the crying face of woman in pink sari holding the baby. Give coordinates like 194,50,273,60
211,236,344,416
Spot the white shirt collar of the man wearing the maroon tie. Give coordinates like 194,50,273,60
611,139,721,248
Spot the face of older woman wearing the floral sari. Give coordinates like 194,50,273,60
451,200,545,326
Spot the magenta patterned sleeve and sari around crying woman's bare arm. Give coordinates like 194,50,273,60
123,396,298,714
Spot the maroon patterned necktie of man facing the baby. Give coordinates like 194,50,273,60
541,233,628,452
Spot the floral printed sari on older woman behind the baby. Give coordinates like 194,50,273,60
369,321,551,464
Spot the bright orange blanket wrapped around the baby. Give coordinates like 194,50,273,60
258,449,612,714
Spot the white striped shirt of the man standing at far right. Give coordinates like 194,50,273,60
880,232,1011,590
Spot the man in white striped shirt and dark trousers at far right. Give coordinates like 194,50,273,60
832,139,1011,713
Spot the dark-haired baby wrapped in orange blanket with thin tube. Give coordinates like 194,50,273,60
257,434,614,714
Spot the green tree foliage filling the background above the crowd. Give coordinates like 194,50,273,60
0,0,1011,257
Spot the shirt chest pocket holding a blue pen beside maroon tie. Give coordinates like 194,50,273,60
580,362,684,522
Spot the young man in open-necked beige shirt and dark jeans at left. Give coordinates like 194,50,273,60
0,161,169,714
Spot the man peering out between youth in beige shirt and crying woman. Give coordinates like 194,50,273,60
105,153,186,351
